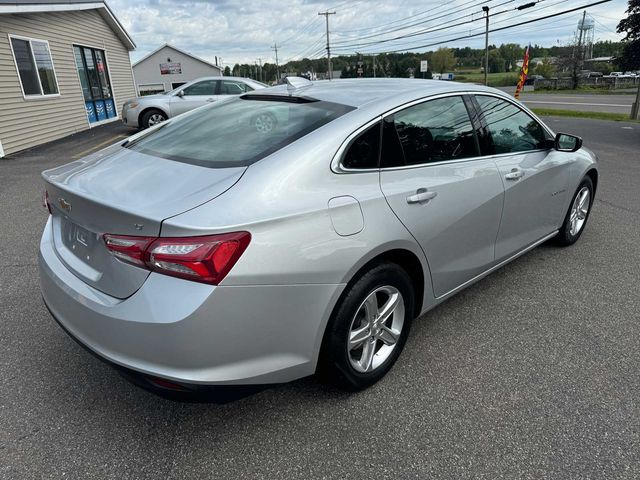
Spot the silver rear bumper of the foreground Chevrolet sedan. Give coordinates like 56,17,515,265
39,221,344,385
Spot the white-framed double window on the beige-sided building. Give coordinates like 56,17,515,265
11,37,58,96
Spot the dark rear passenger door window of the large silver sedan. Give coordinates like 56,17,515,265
383,96,478,167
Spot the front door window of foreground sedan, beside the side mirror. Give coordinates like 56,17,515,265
476,95,547,154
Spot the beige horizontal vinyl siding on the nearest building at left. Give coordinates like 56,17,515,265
0,10,136,155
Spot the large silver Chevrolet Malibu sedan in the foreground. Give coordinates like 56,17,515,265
40,79,598,390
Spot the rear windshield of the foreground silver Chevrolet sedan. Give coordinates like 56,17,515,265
126,95,353,168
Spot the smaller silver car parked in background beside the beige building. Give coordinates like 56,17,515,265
122,77,267,128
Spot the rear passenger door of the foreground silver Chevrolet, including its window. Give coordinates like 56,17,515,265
380,95,504,297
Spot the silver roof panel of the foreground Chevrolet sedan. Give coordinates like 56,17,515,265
245,78,503,108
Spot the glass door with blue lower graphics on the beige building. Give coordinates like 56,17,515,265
73,45,118,123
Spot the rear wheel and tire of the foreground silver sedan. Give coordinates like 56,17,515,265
318,263,415,391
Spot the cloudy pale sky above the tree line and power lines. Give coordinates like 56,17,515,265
107,0,627,66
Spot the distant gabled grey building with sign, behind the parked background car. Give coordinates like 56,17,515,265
133,43,222,95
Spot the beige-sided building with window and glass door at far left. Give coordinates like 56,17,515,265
0,0,136,157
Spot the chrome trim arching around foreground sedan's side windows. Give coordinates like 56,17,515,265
331,90,555,174
